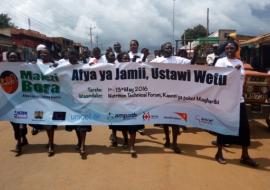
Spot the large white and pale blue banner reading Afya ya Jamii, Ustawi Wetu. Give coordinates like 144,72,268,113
0,63,242,135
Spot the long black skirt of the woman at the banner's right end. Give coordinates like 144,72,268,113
217,103,250,146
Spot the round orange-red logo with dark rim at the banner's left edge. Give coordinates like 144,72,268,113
0,71,19,94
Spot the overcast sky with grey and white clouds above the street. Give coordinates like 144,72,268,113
0,0,270,49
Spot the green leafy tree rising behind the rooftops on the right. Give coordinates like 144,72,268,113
181,24,207,45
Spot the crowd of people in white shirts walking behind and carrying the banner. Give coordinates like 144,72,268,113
1,40,258,167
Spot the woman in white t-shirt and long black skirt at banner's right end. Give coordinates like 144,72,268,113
215,42,258,167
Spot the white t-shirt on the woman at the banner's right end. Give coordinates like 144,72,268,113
215,57,245,103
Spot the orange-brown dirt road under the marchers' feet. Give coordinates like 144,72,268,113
0,121,270,190
